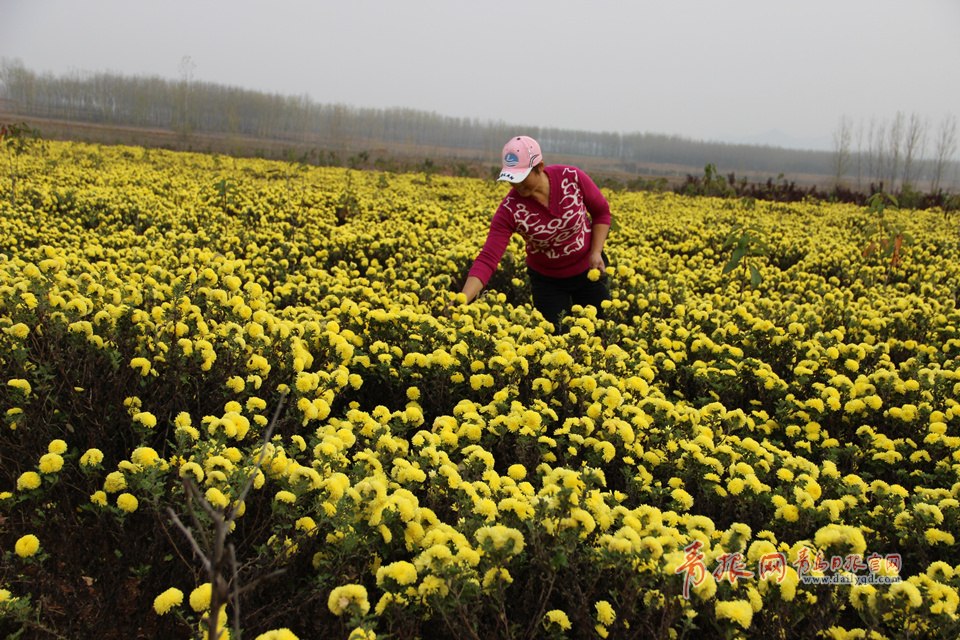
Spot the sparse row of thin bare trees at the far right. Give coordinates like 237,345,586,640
833,111,957,192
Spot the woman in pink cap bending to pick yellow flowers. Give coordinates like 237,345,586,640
463,136,611,328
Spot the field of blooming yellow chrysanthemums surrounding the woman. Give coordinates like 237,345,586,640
0,143,960,640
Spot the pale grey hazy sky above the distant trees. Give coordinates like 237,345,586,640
0,0,960,148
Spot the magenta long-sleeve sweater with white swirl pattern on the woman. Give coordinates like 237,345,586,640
469,165,611,286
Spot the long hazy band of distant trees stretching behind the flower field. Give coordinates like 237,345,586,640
0,58,955,188
